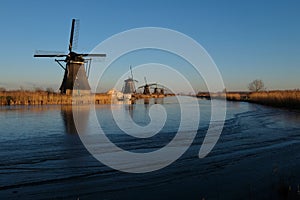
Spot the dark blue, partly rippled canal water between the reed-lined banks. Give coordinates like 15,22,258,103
0,97,300,199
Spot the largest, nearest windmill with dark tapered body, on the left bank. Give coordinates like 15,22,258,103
34,19,106,94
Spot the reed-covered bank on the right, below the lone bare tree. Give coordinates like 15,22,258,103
197,90,300,109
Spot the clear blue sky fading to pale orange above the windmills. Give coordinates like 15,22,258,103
0,0,300,92
